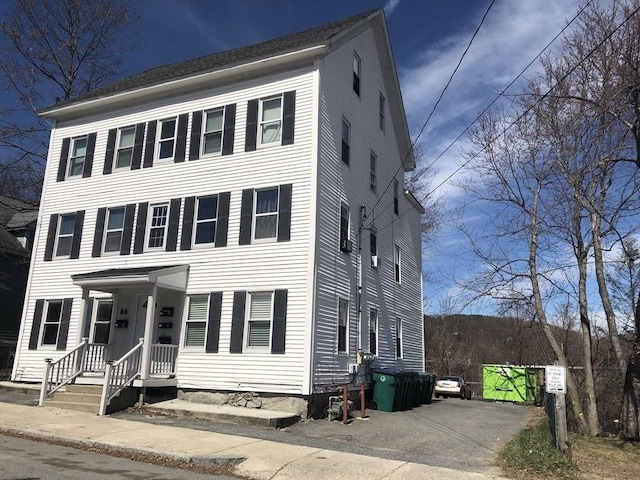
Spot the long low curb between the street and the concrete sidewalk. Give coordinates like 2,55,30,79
0,426,246,467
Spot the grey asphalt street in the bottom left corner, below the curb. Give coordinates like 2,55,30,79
0,435,234,480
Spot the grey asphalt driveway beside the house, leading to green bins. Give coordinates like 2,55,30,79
114,399,535,473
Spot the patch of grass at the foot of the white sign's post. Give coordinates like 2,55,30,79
503,421,580,480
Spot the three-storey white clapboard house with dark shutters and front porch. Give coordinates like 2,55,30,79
12,10,424,412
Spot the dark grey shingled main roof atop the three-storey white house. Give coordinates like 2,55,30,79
43,9,381,110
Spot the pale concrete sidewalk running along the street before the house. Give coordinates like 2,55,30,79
0,386,510,480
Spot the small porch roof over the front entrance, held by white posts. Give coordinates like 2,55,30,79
71,265,189,292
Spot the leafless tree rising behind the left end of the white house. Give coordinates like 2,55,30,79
0,0,132,202
